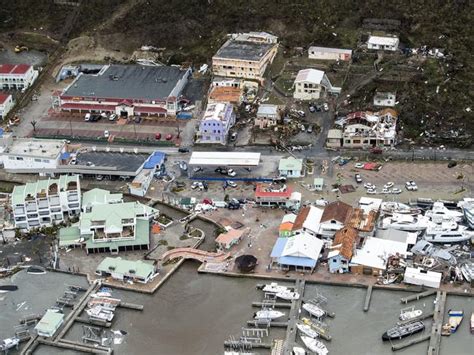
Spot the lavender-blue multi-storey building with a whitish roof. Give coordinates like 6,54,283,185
199,103,235,144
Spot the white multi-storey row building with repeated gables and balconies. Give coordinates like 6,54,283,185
12,175,81,230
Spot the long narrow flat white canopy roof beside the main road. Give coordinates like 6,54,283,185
189,152,260,166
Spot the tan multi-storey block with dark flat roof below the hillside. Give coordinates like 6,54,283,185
212,32,278,82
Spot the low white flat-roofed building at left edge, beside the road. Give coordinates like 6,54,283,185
0,134,66,175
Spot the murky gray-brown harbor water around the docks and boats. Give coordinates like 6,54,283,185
0,262,474,355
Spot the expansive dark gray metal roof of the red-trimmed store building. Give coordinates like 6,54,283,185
63,65,186,100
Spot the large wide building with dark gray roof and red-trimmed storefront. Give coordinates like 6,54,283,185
58,65,191,118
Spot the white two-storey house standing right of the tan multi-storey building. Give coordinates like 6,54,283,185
293,69,341,100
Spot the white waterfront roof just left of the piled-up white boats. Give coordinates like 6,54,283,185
351,237,407,270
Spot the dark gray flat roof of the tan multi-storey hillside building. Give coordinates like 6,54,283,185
214,39,275,61
